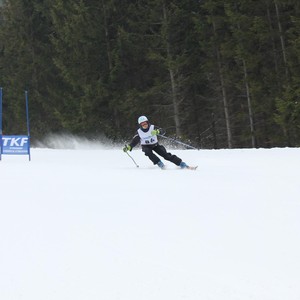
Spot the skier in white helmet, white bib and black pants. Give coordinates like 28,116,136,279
123,116,189,169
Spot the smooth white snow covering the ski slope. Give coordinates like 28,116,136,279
0,145,300,300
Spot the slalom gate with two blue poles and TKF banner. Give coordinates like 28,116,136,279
0,88,31,161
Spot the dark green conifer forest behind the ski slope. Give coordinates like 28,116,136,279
0,0,300,149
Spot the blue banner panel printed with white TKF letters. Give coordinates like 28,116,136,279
1,135,30,155
